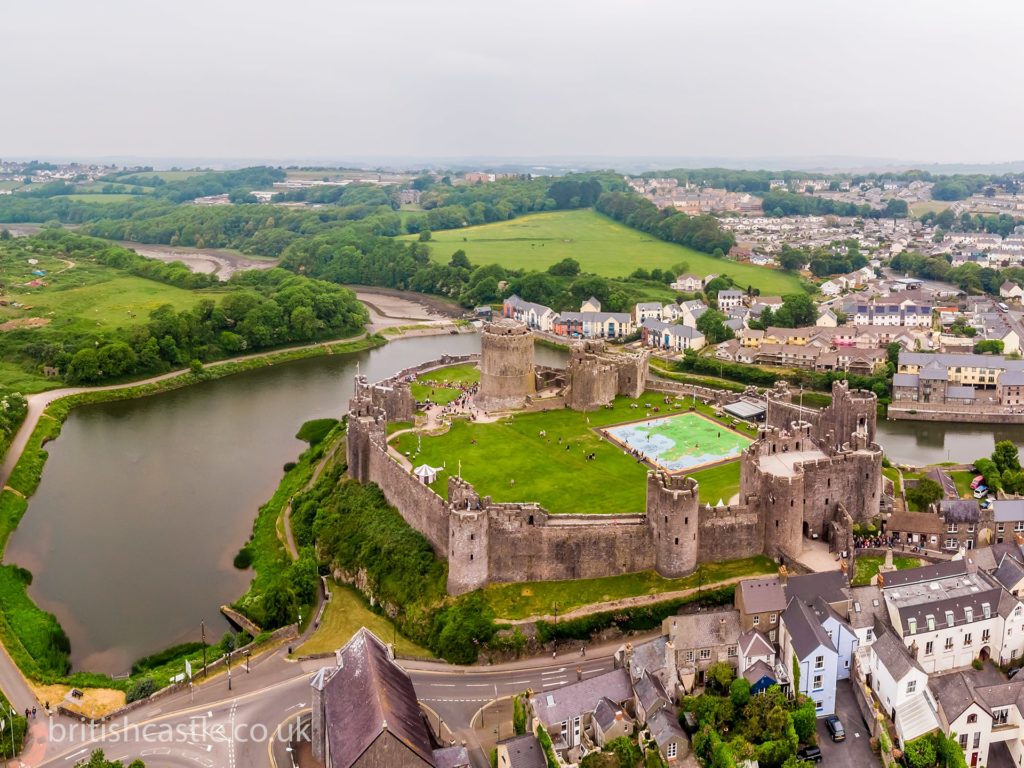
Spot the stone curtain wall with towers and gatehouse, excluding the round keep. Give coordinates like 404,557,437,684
347,358,882,594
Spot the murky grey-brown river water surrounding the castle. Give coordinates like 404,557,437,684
7,334,1024,674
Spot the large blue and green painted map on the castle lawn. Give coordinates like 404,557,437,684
604,413,751,472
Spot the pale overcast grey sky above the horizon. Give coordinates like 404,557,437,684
0,0,1024,162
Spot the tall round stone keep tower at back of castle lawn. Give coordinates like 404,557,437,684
475,318,537,412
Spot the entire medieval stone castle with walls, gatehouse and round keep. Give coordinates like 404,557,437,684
346,319,882,594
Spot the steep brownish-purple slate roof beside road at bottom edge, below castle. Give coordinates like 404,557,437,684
314,628,436,768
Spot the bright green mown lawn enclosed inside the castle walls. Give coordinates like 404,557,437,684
395,393,739,514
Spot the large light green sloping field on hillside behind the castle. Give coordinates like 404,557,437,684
409,210,801,295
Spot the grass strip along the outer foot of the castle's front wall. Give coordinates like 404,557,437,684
483,555,778,620
